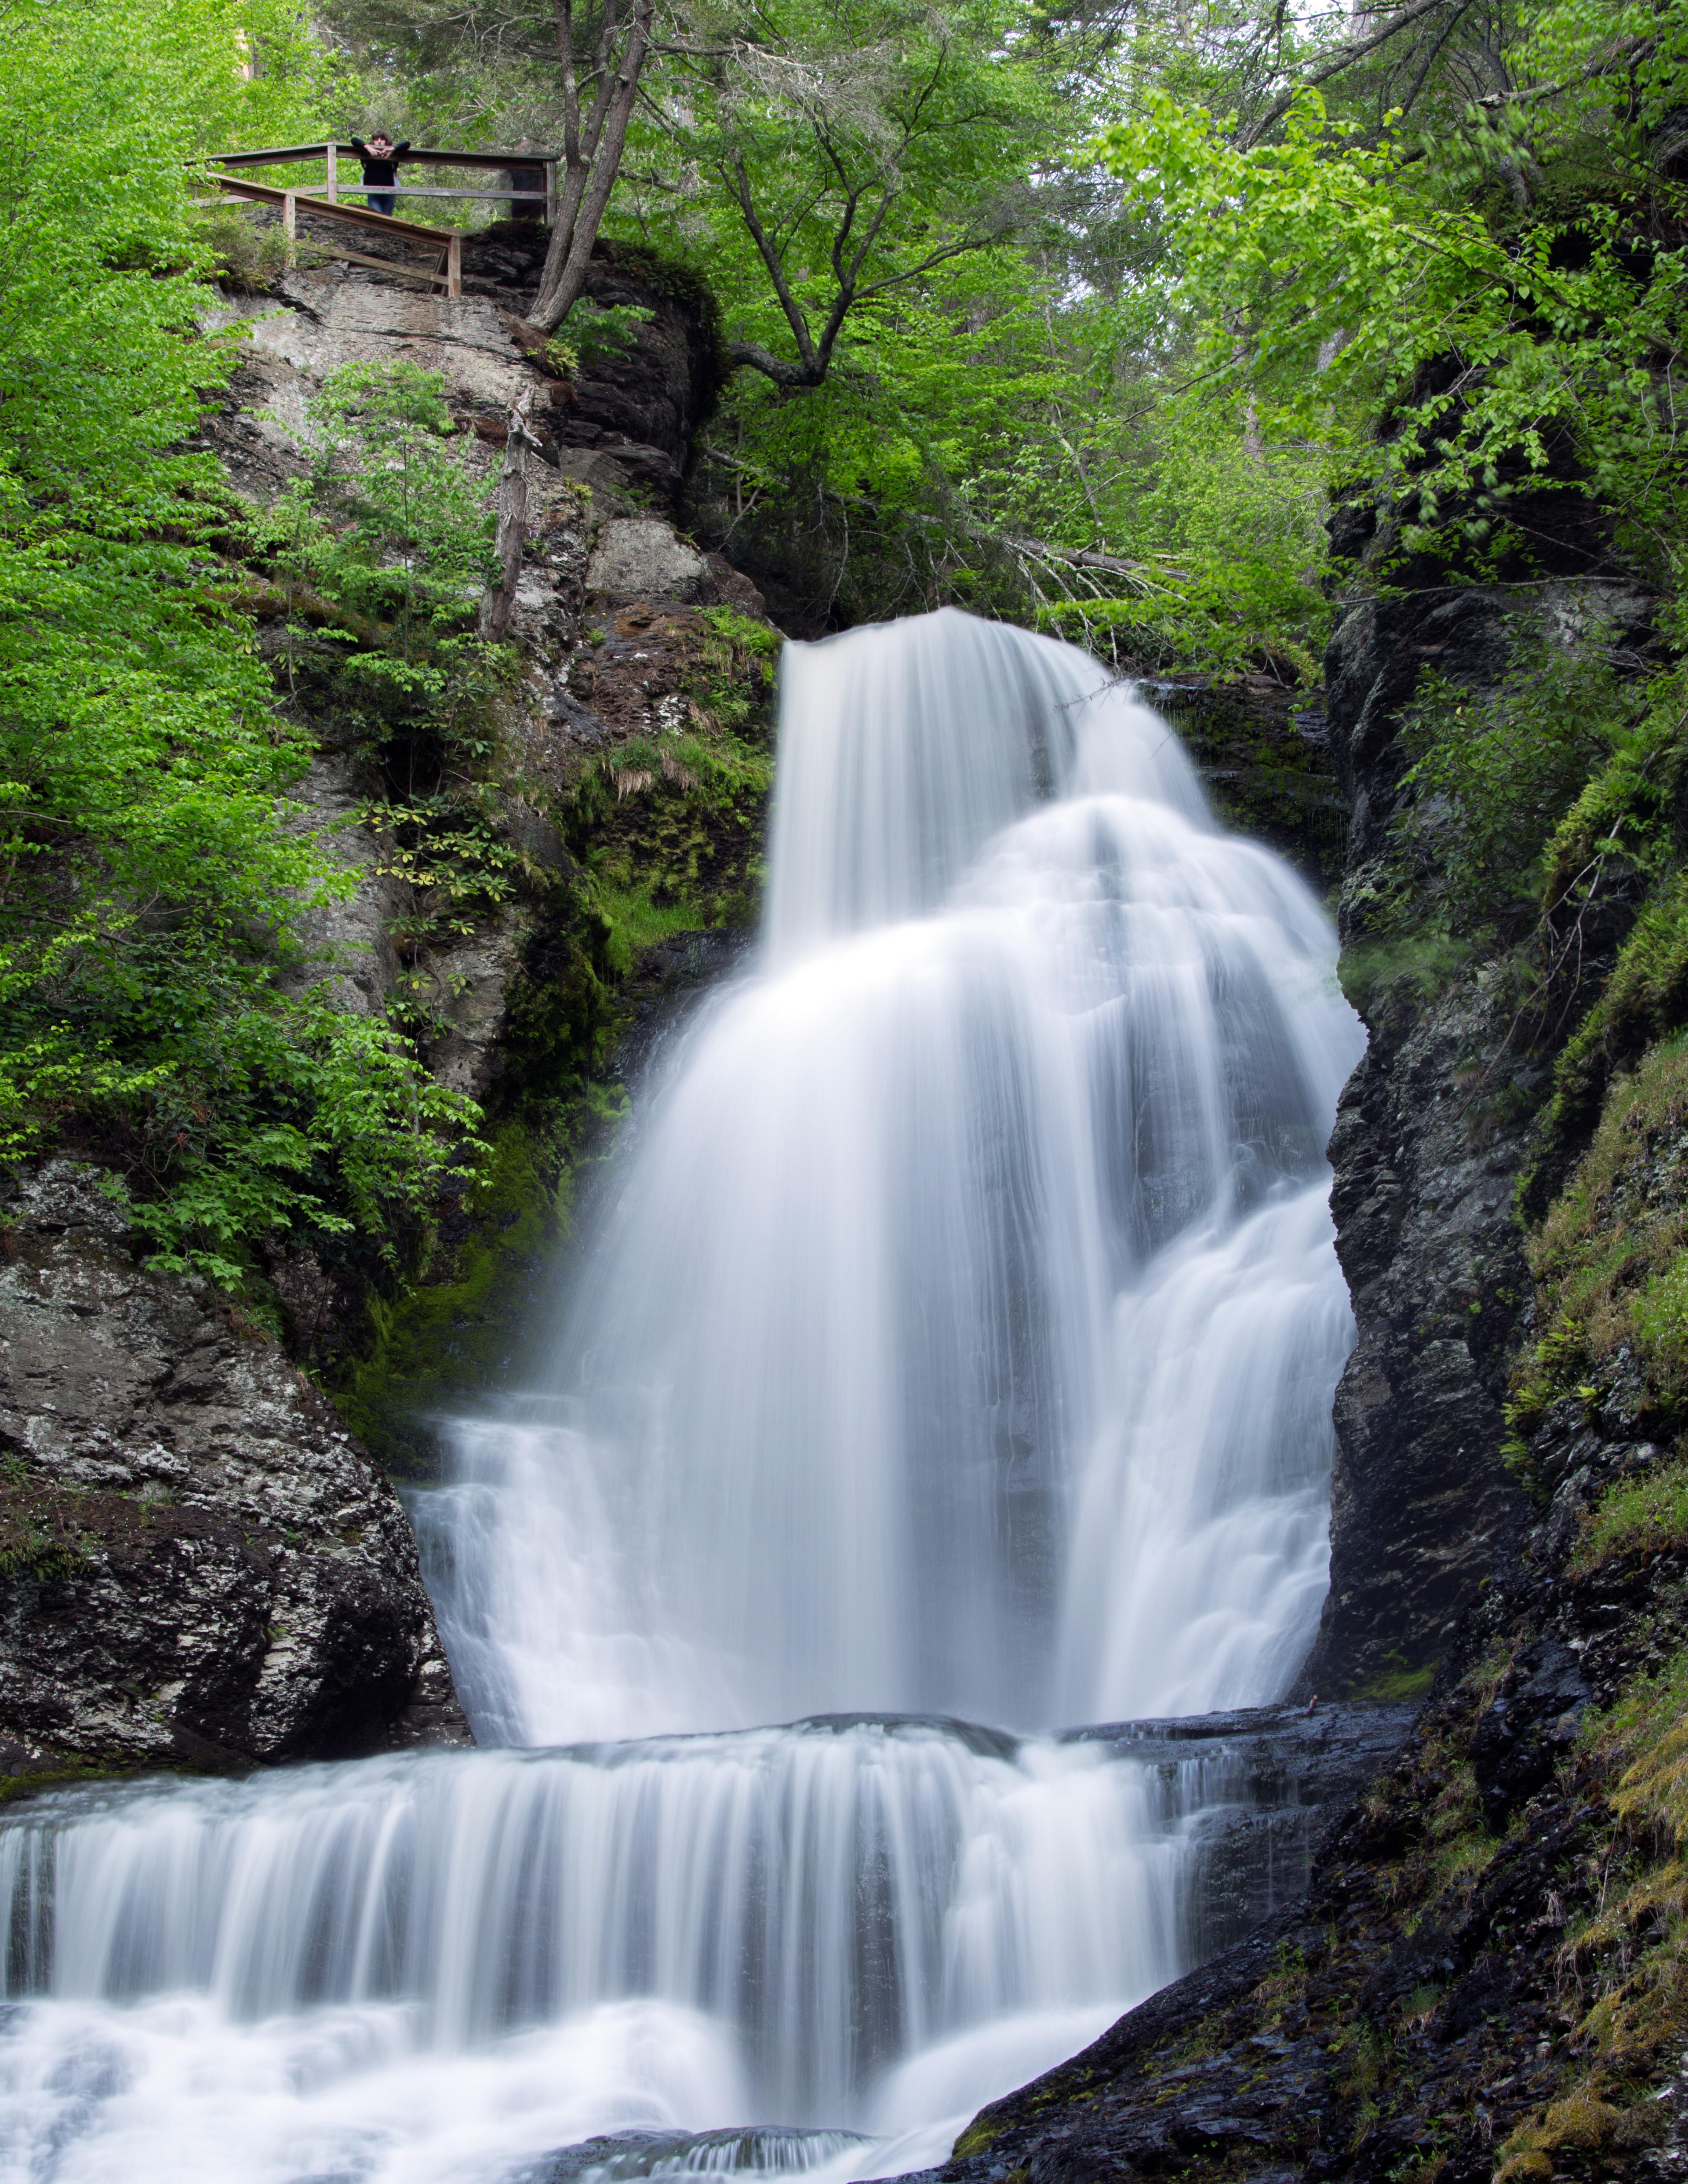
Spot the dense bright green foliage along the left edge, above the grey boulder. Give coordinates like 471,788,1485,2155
0,0,474,1282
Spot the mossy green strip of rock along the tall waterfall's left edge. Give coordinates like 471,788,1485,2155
334,609,782,1476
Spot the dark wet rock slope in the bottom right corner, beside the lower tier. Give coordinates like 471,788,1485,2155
937,1404,1688,2184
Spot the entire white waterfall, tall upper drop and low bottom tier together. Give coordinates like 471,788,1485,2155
0,614,1361,2184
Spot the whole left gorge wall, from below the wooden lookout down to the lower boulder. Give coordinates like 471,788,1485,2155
0,227,779,1795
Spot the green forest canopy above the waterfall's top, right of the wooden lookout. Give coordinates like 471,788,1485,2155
330,0,1688,646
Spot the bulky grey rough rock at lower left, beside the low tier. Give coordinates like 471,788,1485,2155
0,1160,469,1778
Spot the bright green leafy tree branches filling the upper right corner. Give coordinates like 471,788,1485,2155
1101,0,1688,570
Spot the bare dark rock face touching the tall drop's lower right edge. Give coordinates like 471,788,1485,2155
1302,983,1528,1695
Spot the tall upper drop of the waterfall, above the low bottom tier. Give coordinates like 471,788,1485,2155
428,609,1363,1743
